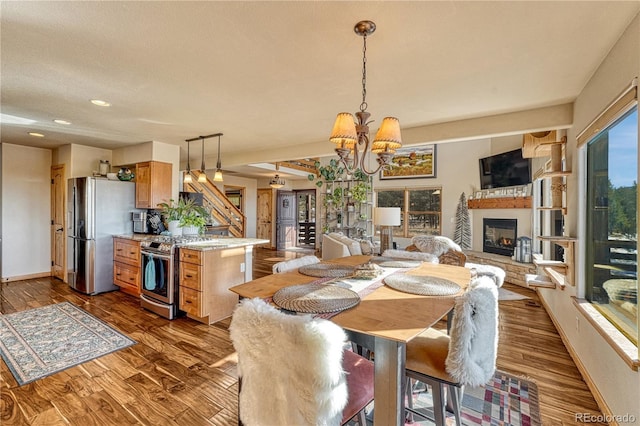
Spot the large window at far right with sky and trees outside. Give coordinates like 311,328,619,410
585,106,638,344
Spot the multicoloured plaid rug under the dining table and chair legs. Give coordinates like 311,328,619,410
407,371,541,426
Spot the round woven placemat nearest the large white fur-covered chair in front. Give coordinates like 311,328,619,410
273,284,360,314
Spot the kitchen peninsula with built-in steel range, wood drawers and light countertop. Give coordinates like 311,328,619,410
114,234,268,324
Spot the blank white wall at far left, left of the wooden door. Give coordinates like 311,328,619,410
2,143,51,280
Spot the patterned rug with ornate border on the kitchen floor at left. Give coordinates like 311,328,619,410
0,302,136,386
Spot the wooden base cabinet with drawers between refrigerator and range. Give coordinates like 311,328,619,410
113,238,141,296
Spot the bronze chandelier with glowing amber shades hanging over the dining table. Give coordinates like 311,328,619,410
329,21,402,175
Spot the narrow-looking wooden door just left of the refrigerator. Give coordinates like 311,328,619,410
51,164,67,281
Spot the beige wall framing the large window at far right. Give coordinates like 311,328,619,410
540,11,640,421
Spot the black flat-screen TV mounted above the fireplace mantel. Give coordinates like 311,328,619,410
480,149,531,189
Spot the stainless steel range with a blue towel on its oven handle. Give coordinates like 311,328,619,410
140,236,213,319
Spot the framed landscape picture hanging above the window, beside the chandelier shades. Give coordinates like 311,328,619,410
380,145,436,179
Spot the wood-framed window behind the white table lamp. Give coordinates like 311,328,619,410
376,188,442,238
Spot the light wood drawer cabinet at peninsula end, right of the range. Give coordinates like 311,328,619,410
179,247,246,324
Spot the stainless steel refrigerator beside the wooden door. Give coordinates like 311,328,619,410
67,177,136,294
